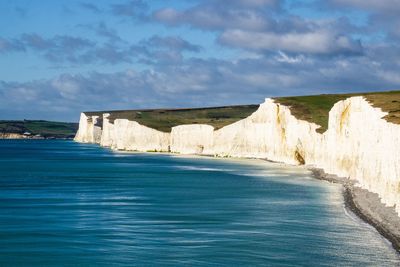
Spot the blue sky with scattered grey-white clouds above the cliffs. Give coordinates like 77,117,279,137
0,0,400,121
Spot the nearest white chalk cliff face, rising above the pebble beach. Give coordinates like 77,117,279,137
316,97,400,214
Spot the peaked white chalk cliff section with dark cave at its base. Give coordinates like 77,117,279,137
214,99,321,164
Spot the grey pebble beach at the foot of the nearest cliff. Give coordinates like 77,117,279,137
309,167,400,253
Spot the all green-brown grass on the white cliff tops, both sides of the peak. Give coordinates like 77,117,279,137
85,91,400,133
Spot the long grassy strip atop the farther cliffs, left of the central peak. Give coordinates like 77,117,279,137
85,105,258,132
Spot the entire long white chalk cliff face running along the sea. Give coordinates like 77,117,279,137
75,97,400,216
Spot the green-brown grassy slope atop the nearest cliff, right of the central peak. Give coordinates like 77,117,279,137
275,91,400,133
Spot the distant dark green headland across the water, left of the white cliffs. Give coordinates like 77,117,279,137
0,120,78,138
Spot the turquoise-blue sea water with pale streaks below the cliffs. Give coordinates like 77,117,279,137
0,140,400,266
